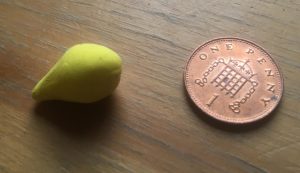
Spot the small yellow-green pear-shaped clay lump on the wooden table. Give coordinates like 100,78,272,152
32,43,121,103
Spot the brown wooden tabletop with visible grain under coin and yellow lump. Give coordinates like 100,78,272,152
0,0,300,173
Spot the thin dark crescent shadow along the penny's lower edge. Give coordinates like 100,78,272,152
184,88,281,133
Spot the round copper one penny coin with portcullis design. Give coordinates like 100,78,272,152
184,38,283,124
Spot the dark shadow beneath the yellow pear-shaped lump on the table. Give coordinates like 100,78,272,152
34,96,115,139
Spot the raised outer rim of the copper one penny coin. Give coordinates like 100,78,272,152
183,37,284,124
